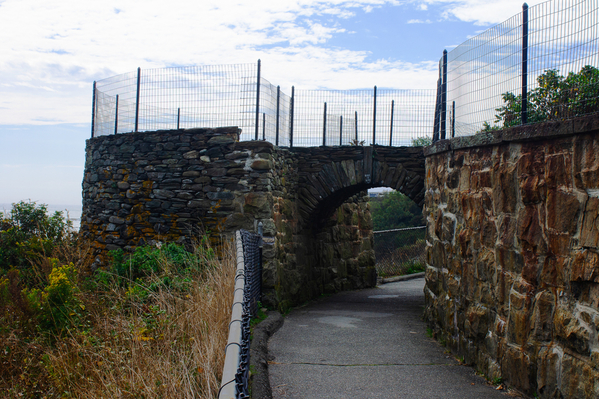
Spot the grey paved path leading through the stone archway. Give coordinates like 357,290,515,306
268,278,520,399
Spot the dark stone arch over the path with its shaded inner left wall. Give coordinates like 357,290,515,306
277,146,425,307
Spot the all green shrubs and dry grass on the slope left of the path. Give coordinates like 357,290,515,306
0,202,235,398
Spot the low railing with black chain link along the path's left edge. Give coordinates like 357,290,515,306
218,228,262,399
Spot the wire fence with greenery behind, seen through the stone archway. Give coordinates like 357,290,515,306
374,226,426,277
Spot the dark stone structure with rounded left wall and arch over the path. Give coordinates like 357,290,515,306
81,127,425,308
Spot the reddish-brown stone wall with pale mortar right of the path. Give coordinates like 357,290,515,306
424,116,599,398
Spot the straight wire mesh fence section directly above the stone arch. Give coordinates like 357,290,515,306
293,87,435,147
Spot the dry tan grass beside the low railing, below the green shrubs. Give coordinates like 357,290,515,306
0,241,235,399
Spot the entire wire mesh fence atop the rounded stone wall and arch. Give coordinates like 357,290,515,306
92,61,435,147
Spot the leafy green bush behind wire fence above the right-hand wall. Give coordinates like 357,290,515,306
483,65,599,131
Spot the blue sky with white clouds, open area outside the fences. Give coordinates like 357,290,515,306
0,0,541,209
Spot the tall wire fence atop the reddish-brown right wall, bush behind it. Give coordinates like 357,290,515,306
433,0,599,140
